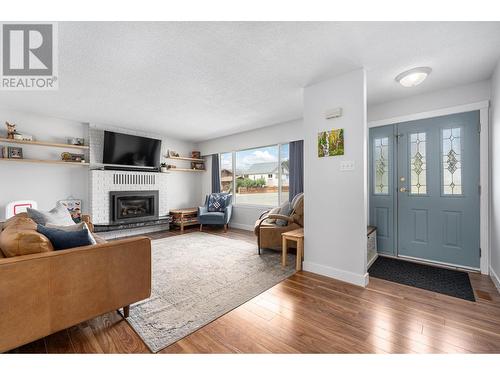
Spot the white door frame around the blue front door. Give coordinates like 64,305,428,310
366,100,490,275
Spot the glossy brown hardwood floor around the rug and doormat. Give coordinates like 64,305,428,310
8,228,500,353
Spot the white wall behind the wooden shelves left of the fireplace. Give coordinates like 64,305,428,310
0,109,88,221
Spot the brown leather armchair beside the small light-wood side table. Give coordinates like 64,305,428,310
254,193,304,254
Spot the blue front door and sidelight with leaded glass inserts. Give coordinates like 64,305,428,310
370,111,480,268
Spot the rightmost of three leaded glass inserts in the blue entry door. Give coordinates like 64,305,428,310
442,128,462,195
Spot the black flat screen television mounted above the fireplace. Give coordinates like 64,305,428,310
102,131,161,168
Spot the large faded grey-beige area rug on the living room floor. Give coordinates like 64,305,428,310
127,233,295,353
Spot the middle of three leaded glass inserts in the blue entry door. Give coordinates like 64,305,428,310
410,133,427,195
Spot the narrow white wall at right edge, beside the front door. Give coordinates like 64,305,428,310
490,62,500,290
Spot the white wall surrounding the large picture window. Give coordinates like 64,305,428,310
198,119,304,230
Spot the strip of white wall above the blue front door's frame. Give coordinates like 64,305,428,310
368,81,491,122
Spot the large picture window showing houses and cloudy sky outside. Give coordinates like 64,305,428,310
220,143,289,206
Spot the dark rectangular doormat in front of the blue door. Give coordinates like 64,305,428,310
368,256,476,302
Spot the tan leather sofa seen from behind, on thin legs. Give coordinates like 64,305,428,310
0,214,151,352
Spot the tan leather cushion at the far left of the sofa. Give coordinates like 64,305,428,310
0,213,54,258
